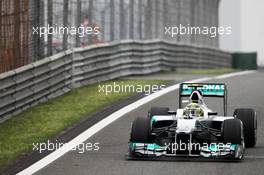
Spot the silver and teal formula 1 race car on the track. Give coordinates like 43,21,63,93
128,83,257,160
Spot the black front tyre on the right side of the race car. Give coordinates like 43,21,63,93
222,119,243,145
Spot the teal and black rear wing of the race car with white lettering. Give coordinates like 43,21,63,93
179,83,227,116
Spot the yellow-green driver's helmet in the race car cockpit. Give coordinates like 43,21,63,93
183,103,204,117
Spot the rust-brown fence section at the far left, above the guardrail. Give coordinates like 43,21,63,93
0,0,29,73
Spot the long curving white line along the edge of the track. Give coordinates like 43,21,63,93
17,71,254,175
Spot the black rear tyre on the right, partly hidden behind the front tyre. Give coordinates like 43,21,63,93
234,109,257,148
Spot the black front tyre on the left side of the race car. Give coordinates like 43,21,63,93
130,117,151,143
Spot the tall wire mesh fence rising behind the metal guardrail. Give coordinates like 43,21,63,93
0,0,219,73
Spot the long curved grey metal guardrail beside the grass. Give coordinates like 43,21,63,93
0,40,232,121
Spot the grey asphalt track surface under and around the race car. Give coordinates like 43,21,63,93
35,71,264,175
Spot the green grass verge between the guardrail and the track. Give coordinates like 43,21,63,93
0,80,167,169
